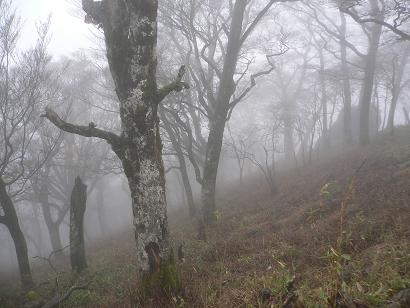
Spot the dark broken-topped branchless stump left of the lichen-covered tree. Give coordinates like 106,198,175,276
70,177,87,273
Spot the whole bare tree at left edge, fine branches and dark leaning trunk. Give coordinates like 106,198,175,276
0,1,57,287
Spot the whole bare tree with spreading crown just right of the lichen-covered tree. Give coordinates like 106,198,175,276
164,0,293,224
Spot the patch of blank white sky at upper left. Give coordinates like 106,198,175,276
13,0,93,58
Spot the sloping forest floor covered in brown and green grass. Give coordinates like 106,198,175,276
0,128,410,307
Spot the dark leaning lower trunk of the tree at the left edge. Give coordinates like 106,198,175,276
0,177,34,289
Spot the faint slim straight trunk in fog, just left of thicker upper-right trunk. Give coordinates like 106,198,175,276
339,11,353,145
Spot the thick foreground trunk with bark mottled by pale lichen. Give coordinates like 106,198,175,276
83,0,172,274
